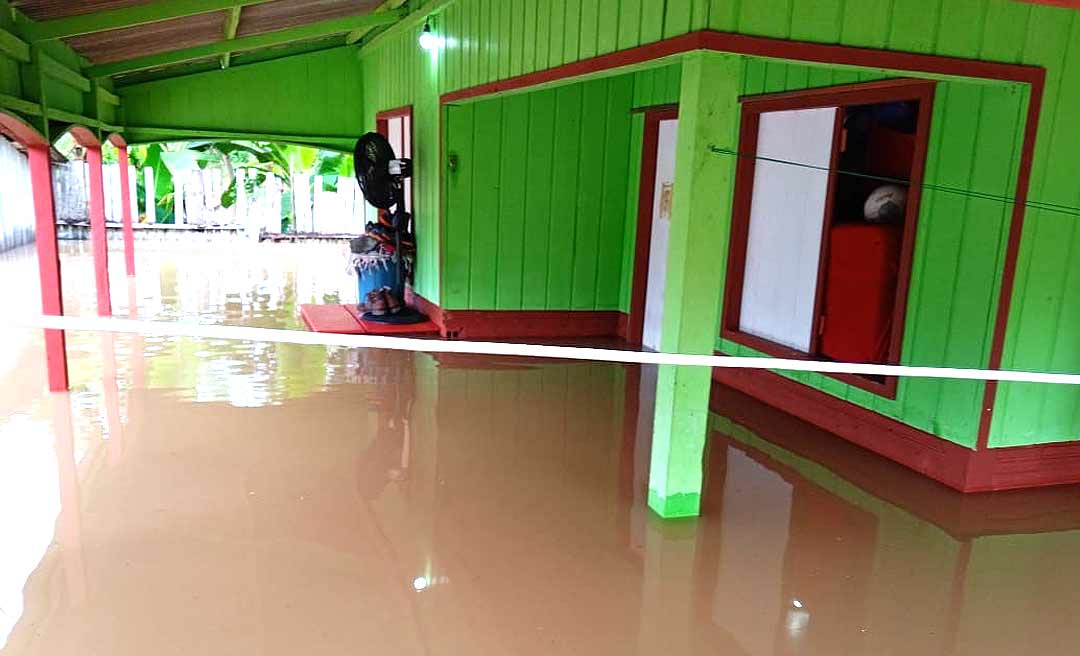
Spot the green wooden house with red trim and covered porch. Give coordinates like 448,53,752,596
0,0,1080,517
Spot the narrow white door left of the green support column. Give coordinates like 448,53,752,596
642,119,678,351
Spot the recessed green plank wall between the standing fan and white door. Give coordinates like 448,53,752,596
444,76,634,310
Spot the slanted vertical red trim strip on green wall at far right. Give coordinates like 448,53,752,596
977,68,1047,450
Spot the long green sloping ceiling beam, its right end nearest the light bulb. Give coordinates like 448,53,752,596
84,9,408,78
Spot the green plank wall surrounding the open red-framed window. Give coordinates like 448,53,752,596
717,58,1027,447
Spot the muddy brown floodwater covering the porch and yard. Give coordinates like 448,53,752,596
0,245,1080,656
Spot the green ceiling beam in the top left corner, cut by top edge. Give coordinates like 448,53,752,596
25,0,272,41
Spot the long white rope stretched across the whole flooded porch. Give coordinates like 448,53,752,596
2,316,1080,385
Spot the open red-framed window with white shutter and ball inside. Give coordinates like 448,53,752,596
721,80,934,398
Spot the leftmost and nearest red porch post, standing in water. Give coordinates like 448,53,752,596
27,146,68,391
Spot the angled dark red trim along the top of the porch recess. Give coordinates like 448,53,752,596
440,30,1041,103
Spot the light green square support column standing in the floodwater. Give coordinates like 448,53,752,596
649,52,742,518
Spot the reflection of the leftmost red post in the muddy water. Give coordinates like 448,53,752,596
50,394,86,606
